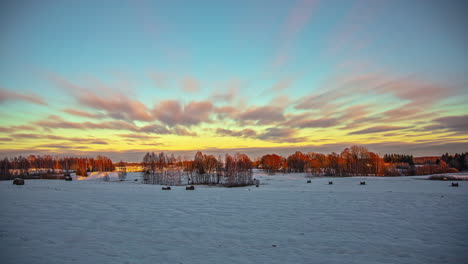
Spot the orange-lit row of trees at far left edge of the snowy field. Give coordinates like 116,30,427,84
0,155,115,180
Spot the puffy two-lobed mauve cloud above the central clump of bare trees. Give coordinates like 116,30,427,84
153,100,214,126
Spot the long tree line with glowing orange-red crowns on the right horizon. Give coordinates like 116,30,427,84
254,146,467,176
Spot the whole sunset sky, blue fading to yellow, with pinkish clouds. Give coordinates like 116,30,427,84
0,0,468,161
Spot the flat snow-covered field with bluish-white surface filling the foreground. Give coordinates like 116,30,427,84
0,172,468,264
